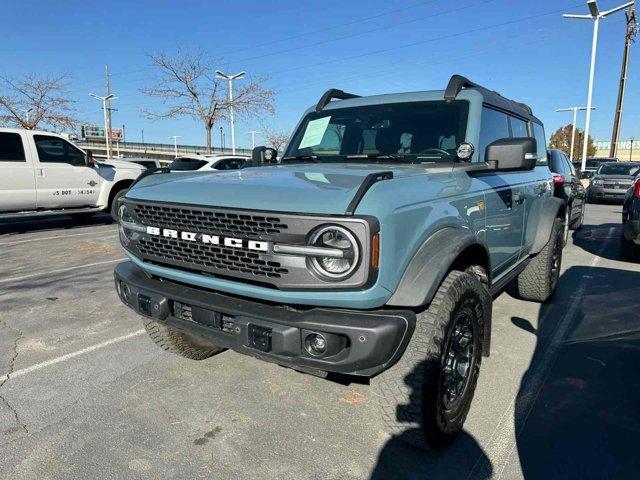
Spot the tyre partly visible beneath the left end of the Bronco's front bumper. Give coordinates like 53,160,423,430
143,319,224,360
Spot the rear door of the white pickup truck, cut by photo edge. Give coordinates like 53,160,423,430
0,132,36,212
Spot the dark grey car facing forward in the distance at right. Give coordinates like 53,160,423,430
587,162,640,203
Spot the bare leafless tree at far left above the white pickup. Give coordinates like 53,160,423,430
0,75,78,130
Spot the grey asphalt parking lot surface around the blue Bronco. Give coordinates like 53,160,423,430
0,205,640,480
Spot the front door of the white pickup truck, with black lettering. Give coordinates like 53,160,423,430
33,135,102,209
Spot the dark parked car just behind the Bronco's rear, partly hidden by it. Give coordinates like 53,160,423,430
549,149,585,243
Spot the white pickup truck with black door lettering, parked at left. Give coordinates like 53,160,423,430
0,128,145,223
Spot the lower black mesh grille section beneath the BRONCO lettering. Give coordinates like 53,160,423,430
138,237,288,278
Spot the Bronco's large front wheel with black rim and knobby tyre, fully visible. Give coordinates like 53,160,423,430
372,271,491,449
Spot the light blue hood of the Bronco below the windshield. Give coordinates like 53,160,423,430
127,163,425,214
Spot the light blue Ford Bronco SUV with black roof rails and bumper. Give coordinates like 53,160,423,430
115,75,564,448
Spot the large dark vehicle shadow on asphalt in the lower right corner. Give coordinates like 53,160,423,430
512,264,640,480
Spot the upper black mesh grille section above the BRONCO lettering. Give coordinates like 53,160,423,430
134,204,287,238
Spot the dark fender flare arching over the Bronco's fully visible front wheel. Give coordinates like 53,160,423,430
387,227,490,307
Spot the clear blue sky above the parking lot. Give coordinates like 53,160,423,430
0,0,640,146
